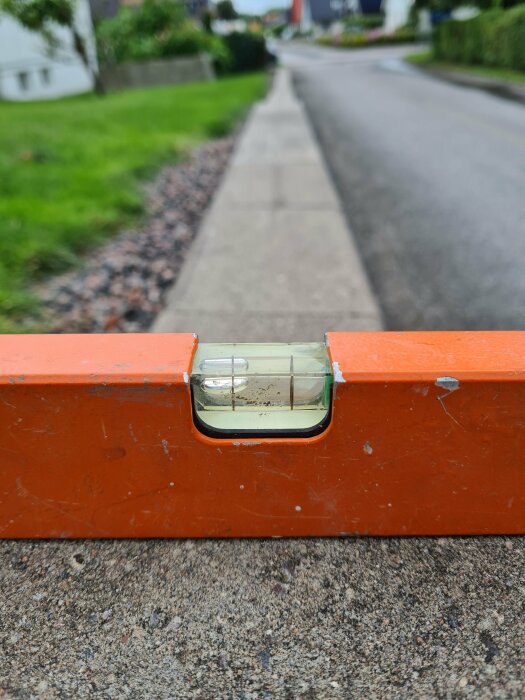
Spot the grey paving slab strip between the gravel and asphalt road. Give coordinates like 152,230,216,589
152,70,382,342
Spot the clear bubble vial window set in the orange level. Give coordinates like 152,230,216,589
190,343,332,437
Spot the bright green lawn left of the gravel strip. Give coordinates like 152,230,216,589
0,74,266,332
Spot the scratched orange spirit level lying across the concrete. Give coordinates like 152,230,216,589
0,332,525,537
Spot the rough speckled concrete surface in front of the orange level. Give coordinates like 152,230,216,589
0,538,525,700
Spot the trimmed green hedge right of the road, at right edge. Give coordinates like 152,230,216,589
433,5,525,71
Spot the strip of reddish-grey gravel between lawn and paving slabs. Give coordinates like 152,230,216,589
39,138,234,333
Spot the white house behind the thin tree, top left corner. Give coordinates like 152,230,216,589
0,0,97,101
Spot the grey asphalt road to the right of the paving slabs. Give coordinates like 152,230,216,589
281,46,525,330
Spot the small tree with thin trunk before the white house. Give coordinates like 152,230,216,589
0,0,104,94
